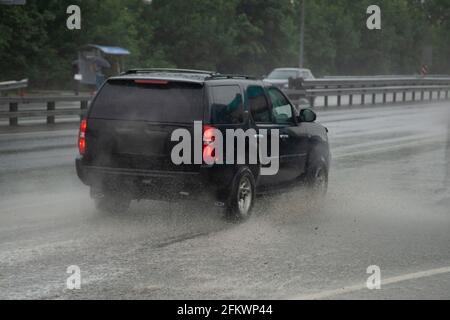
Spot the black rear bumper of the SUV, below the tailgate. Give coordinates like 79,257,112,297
75,158,234,203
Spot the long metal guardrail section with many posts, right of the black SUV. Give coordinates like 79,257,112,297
284,76,450,107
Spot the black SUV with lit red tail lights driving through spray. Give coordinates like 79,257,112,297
76,69,330,220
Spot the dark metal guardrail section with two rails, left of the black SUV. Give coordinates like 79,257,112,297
0,95,92,126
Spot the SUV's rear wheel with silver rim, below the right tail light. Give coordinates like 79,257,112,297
227,167,256,222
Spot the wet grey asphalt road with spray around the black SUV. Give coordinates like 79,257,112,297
0,103,450,299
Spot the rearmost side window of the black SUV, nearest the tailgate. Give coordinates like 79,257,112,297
211,86,244,124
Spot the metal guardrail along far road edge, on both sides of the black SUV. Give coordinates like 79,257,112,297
0,77,450,126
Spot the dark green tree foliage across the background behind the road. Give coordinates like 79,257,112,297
0,0,450,88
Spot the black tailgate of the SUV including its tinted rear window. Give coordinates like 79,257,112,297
86,79,205,171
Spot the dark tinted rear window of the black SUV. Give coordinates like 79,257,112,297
89,80,203,123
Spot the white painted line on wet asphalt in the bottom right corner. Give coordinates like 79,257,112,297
290,267,450,300
